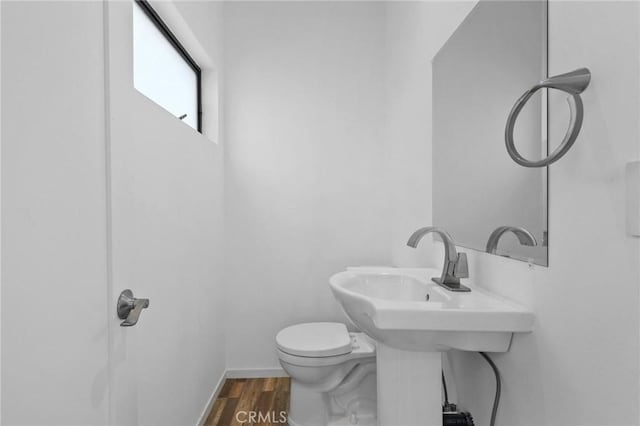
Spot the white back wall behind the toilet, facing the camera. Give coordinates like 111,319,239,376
225,2,390,369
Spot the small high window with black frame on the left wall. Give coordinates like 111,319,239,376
133,0,202,133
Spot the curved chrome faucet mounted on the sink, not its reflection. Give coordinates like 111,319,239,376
407,226,471,291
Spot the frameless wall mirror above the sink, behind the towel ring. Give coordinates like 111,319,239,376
433,0,548,266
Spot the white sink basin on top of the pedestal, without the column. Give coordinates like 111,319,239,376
329,268,534,352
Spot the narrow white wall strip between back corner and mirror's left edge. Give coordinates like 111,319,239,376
384,1,475,266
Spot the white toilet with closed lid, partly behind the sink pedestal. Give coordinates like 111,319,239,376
276,322,376,426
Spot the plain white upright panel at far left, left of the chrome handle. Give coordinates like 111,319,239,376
1,2,113,425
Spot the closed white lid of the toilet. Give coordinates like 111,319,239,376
276,322,351,357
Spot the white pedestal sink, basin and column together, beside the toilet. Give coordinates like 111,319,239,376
330,268,534,426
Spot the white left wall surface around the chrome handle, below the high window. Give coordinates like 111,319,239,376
106,2,224,426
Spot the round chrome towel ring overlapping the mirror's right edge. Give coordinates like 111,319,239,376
504,68,591,167
